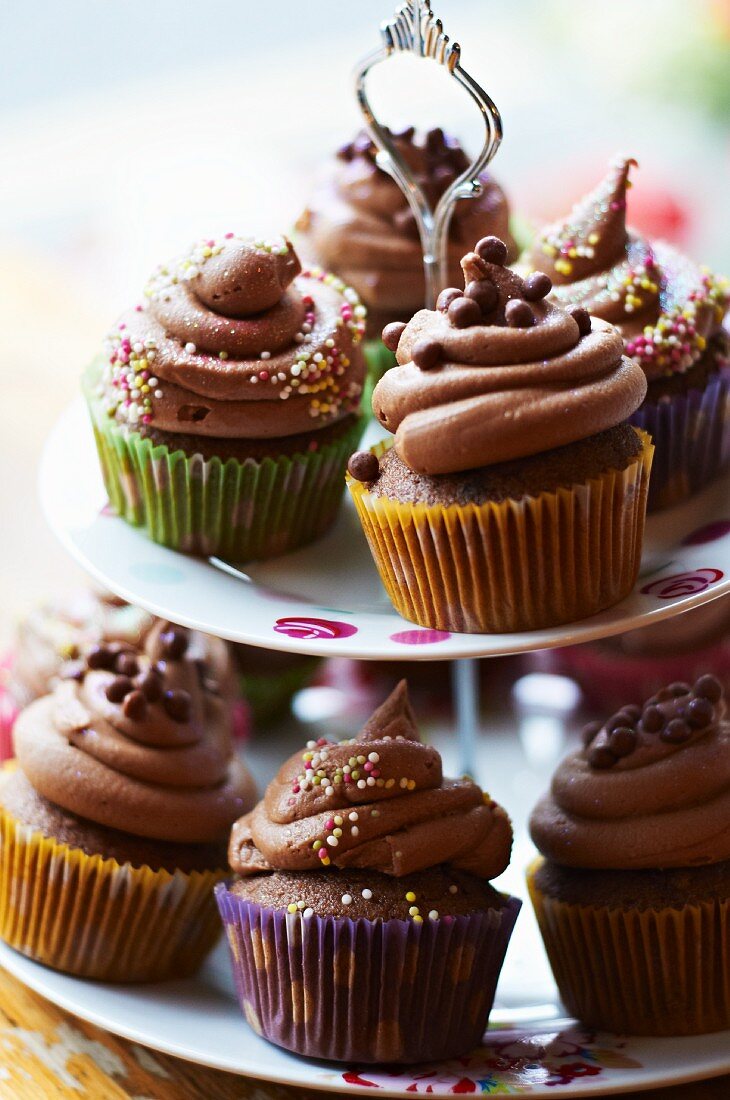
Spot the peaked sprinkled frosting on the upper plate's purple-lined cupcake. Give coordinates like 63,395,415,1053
527,157,728,381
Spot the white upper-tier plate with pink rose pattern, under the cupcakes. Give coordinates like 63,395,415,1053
40,398,730,661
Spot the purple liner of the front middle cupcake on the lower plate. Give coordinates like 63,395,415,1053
215,883,522,1063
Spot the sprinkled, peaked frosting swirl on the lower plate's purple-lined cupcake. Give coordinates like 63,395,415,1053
229,681,512,879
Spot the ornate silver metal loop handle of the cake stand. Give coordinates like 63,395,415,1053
355,0,502,309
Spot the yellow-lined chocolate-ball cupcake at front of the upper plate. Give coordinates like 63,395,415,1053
349,237,652,633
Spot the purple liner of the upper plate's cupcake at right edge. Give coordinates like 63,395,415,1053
630,365,730,512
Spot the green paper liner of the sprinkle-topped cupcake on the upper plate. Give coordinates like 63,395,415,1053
85,374,365,562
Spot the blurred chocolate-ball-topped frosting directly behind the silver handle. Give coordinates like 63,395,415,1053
297,127,517,337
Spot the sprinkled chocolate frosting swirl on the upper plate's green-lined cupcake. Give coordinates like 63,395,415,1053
100,233,365,439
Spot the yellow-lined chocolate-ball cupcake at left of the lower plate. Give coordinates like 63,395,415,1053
0,622,255,981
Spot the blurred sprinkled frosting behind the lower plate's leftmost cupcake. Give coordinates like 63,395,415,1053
9,589,235,706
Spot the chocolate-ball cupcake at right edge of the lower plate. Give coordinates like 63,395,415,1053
528,675,730,1035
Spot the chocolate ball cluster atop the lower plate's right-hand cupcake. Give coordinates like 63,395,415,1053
583,675,722,769
